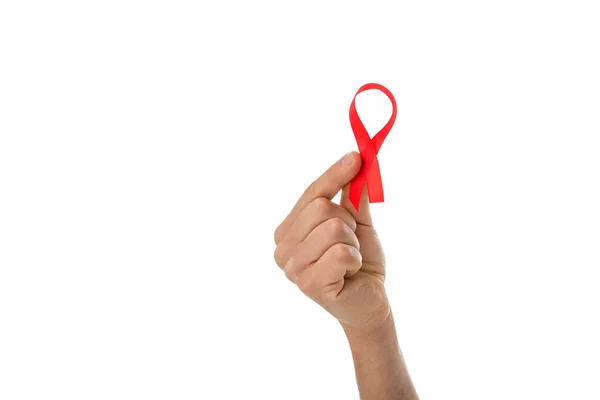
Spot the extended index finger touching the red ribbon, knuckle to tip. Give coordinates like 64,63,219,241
275,151,361,243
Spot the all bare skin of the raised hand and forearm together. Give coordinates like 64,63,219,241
275,152,418,400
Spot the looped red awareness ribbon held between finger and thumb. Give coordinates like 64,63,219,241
349,83,396,211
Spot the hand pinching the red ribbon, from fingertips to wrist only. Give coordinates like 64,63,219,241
275,152,390,332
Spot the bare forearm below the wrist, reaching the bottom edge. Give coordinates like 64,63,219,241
344,312,418,400
